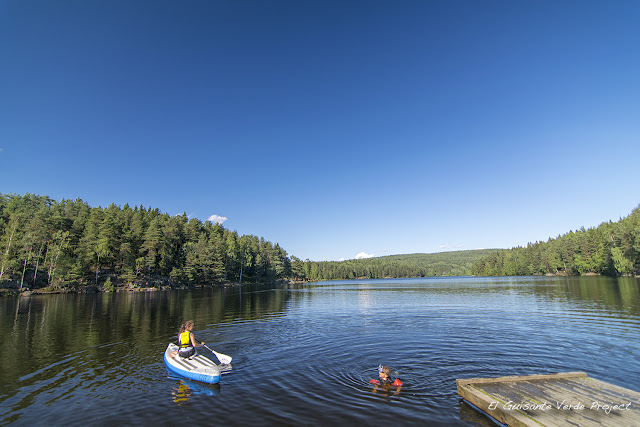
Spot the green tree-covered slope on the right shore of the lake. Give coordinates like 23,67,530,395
473,206,640,276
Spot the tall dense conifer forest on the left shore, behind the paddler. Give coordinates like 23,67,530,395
0,194,291,288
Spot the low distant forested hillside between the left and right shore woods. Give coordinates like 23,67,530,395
293,249,496,280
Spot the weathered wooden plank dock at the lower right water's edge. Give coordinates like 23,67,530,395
456,372,640,427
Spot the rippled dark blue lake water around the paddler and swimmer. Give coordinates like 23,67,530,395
0,277,640,425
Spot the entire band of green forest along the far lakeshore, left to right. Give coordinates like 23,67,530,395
0,194,640,290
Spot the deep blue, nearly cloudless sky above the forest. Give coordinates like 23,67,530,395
0,0,640,261
